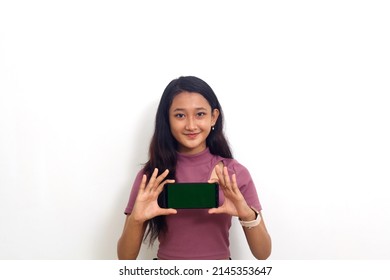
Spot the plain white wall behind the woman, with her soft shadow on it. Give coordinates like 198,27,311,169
0,0,390,260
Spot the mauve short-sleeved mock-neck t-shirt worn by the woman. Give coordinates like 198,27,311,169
125,148,261,260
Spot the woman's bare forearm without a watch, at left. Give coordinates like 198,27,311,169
117,214,146,260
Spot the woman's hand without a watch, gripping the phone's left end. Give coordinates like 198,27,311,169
131,168,177,223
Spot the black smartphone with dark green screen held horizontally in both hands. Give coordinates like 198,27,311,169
159,183,219,209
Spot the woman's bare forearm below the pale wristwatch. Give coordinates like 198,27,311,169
243,213,272,260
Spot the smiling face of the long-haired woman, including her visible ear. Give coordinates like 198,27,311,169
169,91,219,154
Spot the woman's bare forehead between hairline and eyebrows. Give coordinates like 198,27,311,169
170,91,211,110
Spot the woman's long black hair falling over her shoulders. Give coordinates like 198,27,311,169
144,76,233,244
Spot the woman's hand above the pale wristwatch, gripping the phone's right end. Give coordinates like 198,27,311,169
209,165,253,217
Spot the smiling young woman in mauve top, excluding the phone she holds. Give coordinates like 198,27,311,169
118,76,271,260
